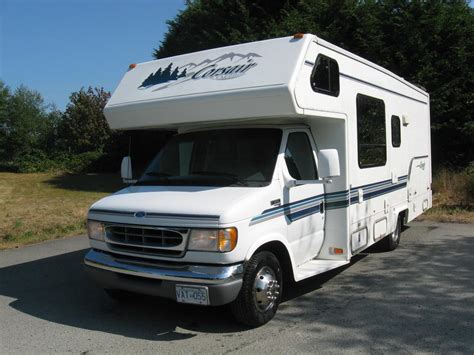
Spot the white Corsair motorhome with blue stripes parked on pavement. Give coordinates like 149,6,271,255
85,34,432,326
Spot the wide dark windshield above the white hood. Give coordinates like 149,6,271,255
137,128,282,187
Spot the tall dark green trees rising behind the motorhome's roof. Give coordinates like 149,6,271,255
154,0,474,165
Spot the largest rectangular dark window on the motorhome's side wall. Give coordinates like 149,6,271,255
356,94,387,168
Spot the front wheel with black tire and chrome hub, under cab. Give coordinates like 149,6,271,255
231,251,283,327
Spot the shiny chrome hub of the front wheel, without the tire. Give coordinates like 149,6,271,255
253,266,280,312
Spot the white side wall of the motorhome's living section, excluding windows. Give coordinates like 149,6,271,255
295,39,431,259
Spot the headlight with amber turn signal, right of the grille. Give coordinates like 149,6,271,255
188,227,237,252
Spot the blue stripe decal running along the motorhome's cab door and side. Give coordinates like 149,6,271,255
250,175,408,224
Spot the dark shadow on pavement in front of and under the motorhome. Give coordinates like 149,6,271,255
0,249,360,341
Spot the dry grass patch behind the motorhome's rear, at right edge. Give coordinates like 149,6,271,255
417,169,474,223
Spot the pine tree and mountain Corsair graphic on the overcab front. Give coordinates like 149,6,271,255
138,52,261,91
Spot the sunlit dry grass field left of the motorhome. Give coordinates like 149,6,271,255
0,173,122,249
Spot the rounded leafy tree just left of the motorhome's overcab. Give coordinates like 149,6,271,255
59,87,112,153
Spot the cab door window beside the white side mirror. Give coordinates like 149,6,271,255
285,132,318,180
